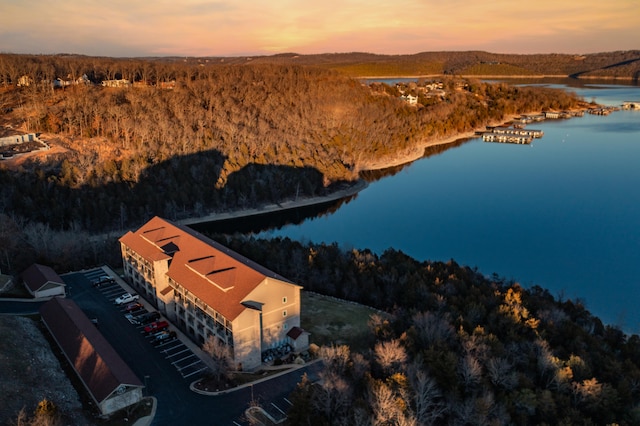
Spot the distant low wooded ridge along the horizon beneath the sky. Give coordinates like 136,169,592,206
179,50,640,81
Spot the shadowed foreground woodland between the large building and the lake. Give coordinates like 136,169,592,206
214,236,640,425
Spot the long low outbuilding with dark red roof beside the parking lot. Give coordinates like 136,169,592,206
40,297,144,416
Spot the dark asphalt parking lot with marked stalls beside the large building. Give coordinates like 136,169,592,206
62,268,318,426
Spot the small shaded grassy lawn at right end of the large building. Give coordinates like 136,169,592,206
301,291,377,351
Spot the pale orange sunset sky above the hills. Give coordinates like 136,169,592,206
0,0,640,56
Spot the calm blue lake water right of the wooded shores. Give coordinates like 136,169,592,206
262,81,640,333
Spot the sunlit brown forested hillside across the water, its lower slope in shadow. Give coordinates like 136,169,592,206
0,55,583,270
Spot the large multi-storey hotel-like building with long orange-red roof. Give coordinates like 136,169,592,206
120,217,306,370
